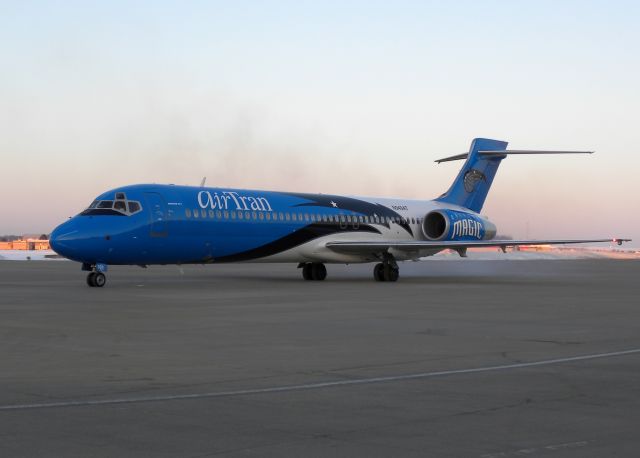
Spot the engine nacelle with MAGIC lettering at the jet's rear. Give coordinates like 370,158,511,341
422,209,496,241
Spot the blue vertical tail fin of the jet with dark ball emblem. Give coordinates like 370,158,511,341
436,138,508,212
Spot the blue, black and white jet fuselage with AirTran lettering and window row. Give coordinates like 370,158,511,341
51,185,492,265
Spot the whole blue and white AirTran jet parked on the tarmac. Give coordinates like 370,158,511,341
50,138,629,287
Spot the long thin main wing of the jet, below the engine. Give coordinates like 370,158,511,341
326,239,631,254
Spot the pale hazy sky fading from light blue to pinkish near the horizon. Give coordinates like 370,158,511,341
0,0,640,246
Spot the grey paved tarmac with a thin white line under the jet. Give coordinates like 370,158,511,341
0,260,640,458
